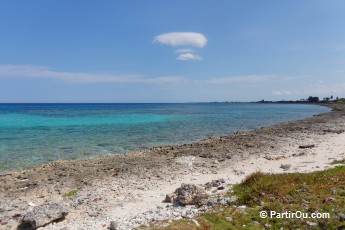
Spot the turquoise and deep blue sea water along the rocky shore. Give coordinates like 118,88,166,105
0,103,329,172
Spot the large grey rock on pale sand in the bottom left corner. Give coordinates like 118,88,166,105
21,203,68,229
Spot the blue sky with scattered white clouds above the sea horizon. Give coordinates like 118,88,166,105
0,0,345,103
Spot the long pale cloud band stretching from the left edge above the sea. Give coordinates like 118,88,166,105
0,65,184,84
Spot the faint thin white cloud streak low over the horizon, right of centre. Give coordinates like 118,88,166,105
208,75,274,84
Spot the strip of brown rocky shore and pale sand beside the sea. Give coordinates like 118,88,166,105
0,104,345,229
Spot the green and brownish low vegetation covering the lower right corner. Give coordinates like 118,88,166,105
150,166,345,230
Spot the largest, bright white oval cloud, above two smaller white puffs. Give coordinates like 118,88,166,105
153,32,207,48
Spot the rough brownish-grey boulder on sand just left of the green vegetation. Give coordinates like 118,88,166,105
175,184,208,205
